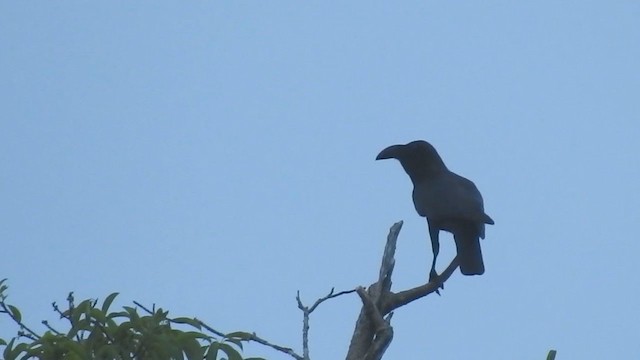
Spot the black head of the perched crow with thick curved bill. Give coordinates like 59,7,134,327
376,140,447,183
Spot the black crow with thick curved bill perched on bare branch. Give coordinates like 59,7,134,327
376,140,494,280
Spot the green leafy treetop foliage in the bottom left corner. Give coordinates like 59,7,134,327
0,279,262,360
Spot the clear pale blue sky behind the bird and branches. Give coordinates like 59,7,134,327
0,0,640,360
